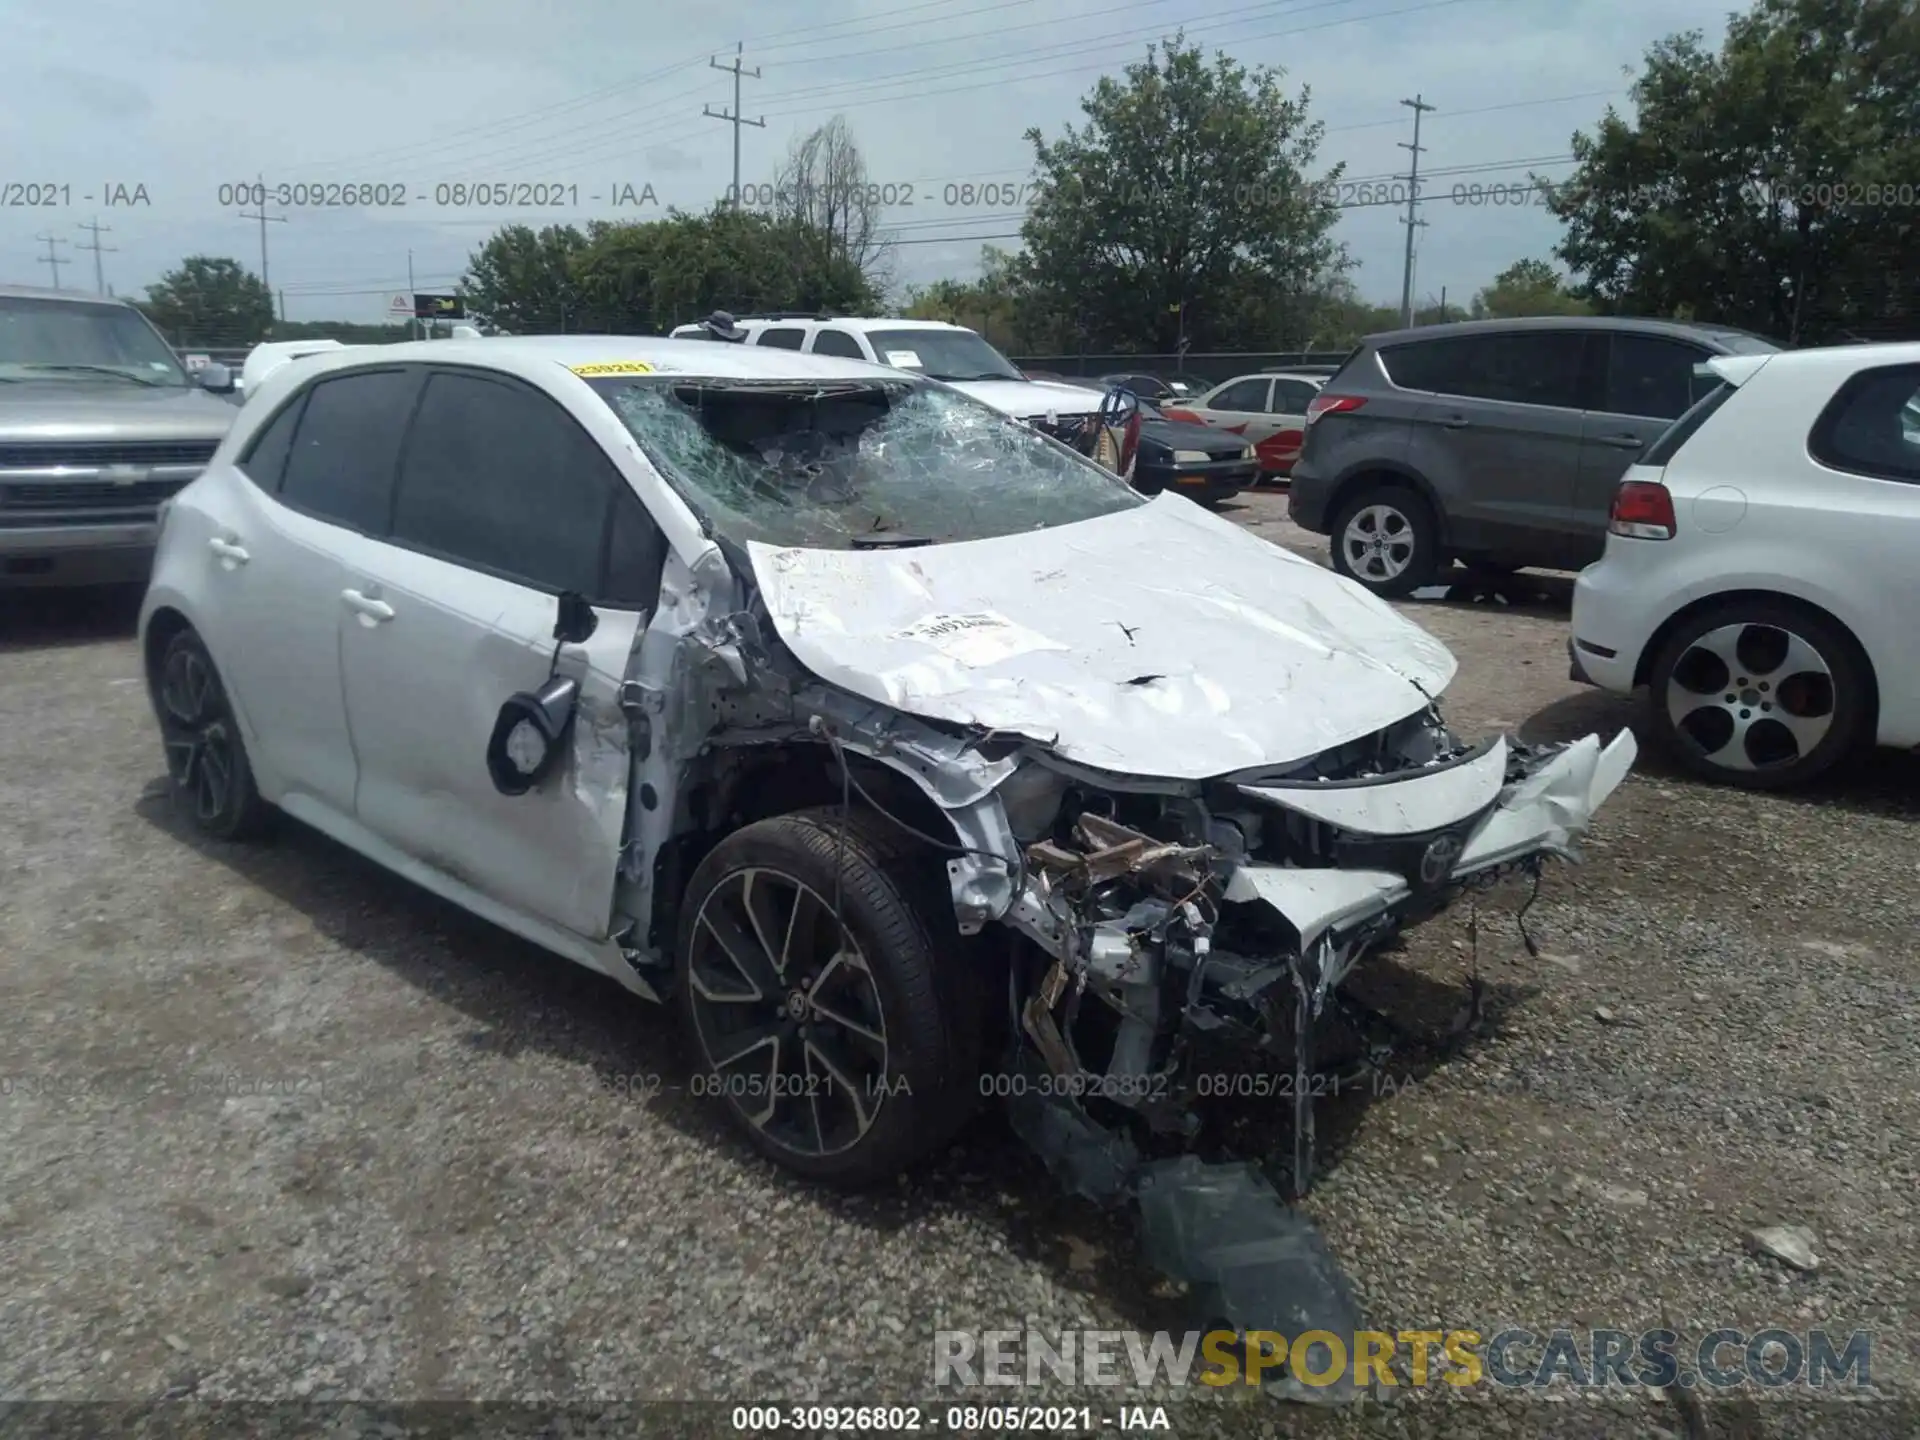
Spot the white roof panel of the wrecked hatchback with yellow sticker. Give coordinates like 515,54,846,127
286,334,900,380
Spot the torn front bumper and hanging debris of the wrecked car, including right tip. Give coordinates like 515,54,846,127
983,733,1636,1196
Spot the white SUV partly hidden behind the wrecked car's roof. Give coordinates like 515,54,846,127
672,315,1102,430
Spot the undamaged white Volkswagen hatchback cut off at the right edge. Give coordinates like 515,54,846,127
1569,344,1920,789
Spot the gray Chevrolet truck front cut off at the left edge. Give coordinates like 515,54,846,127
0,286,238,586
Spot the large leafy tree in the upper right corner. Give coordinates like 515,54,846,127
1542,0,1920,344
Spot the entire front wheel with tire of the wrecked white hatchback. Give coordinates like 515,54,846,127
676,810,993,1187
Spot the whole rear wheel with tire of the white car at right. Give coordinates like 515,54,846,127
1647,597,1872,789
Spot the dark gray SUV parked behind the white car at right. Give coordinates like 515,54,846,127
1288,317,1778,595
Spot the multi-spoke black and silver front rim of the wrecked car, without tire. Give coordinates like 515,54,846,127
687,868,887,1158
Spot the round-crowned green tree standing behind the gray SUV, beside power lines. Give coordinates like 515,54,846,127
1014,35,1350,353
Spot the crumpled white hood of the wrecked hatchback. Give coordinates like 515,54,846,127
749,495,1455,780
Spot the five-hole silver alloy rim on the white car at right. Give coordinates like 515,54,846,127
1661,624,1837,770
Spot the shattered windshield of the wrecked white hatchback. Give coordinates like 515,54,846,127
589,376,1142,549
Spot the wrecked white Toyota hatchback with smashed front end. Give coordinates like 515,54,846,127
140,336,1634,1183
